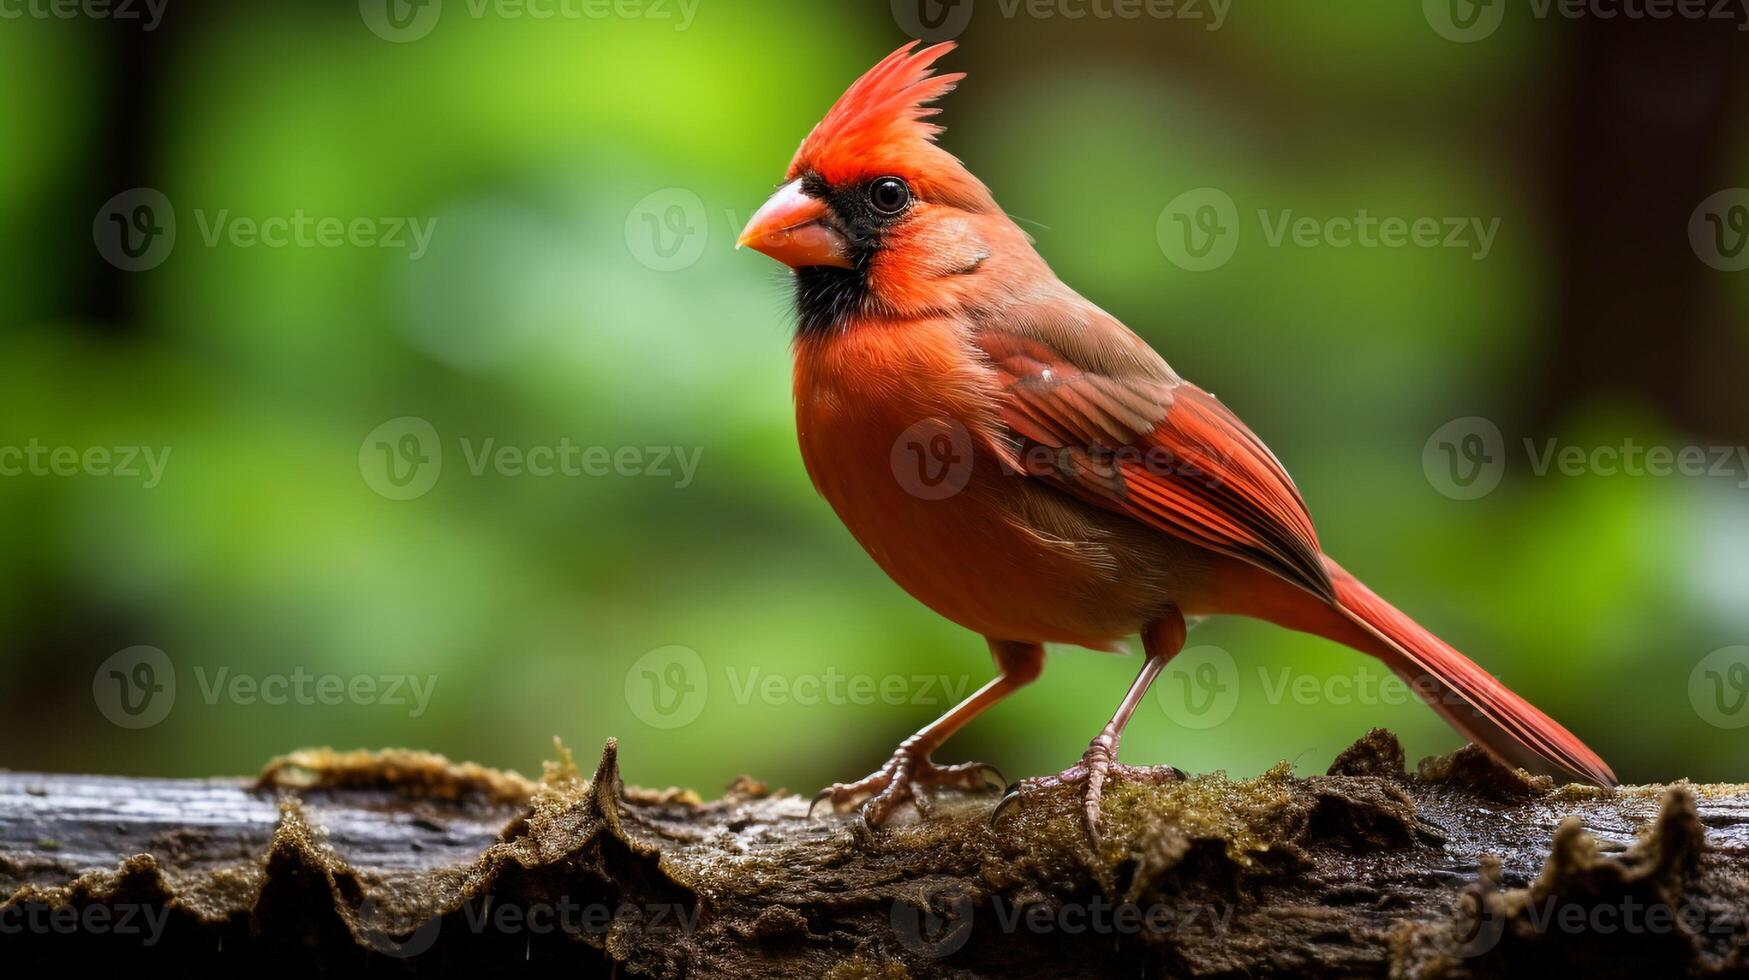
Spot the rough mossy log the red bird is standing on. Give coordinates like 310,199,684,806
0,730,1749,978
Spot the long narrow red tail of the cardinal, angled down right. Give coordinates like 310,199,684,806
1313,557,1616,786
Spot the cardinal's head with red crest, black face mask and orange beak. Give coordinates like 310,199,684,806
736,40,1007,331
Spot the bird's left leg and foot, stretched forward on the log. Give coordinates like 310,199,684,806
810,641,1044,826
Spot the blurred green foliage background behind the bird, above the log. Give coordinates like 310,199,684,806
0,0,1749,795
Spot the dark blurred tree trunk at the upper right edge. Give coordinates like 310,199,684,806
1523,13,1749,445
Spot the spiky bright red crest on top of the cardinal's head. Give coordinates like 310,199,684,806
789,40,988,207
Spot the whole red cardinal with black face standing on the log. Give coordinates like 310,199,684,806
740,42,1614,838
